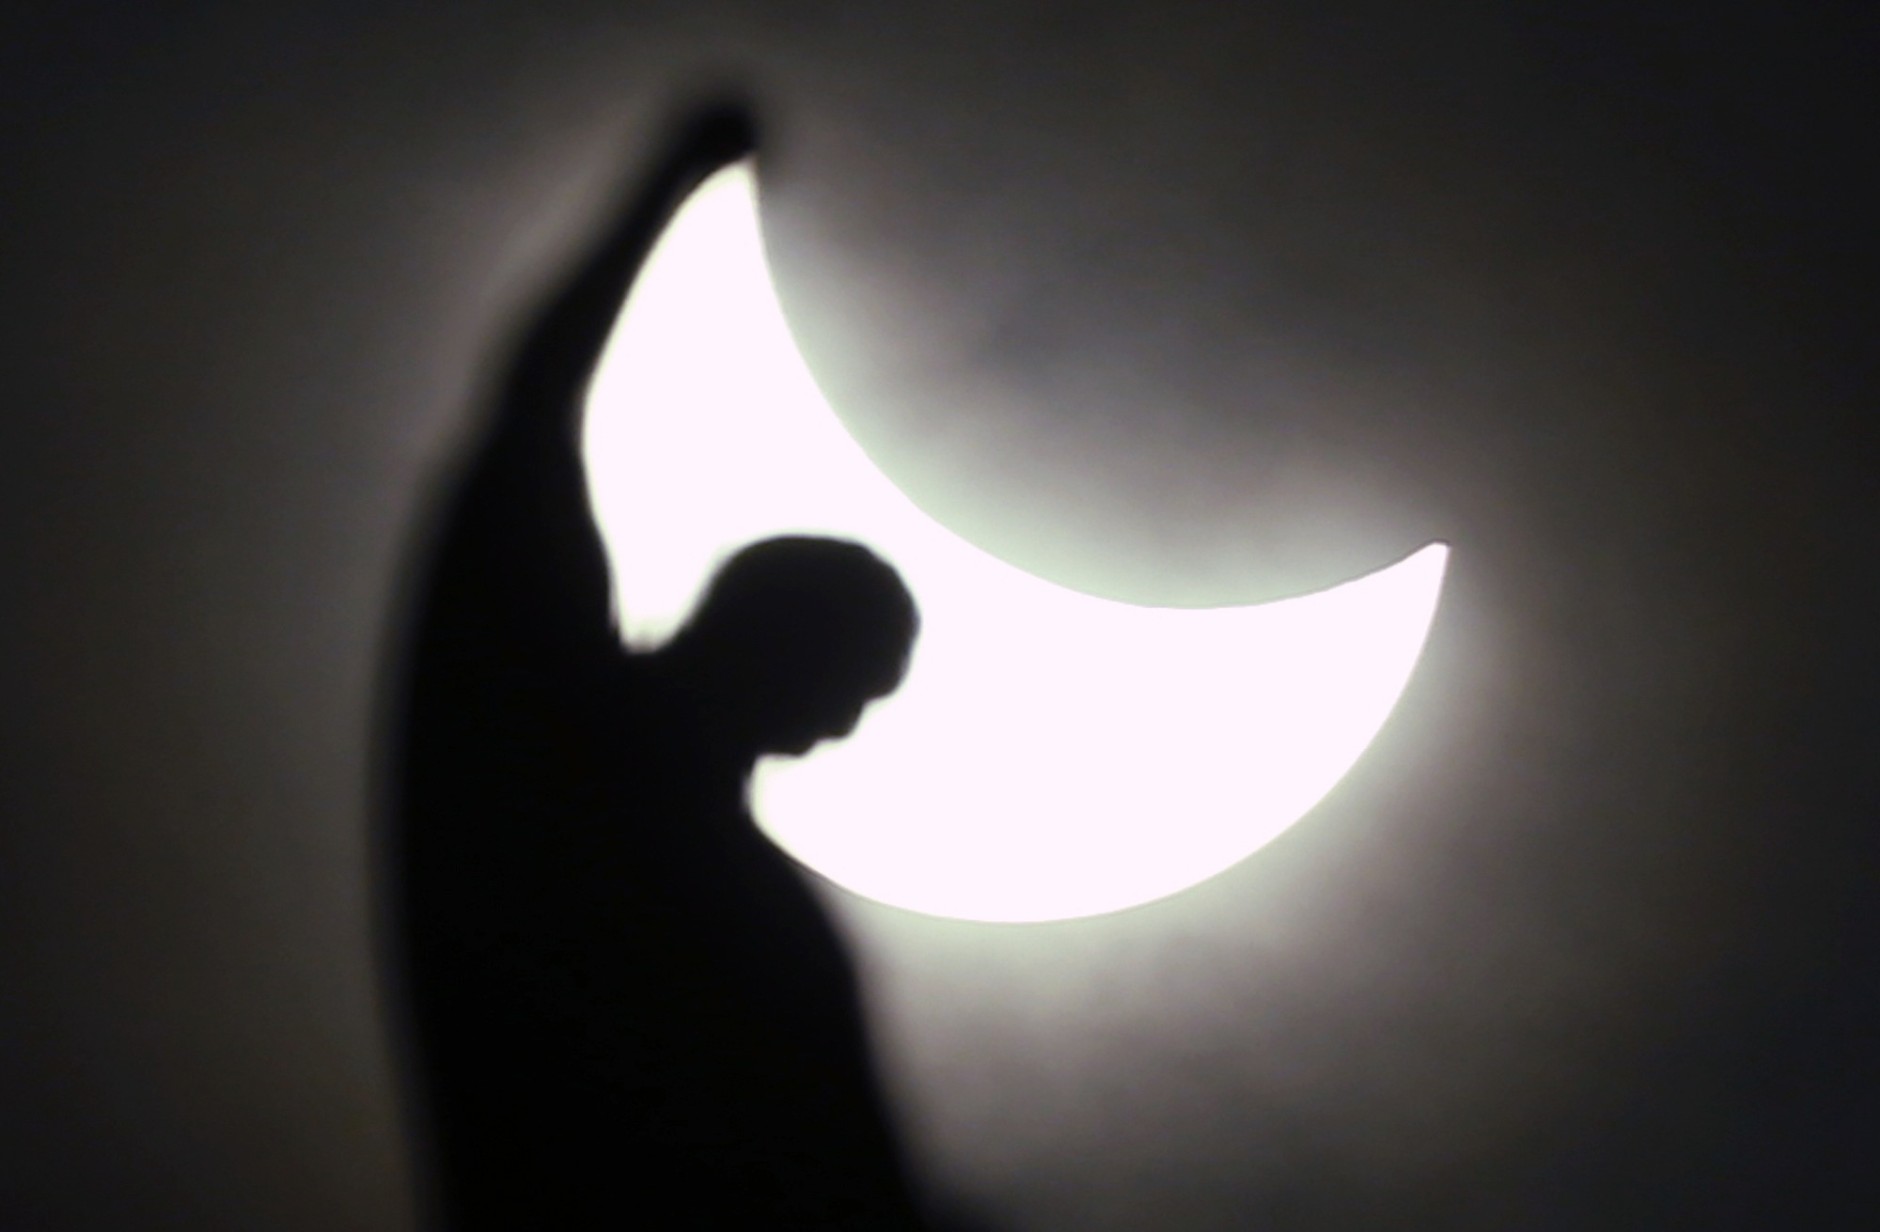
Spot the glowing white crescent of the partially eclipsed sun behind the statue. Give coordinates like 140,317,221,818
585,162,1448,922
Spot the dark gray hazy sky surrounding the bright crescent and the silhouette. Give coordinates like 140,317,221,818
0,0,1880,1232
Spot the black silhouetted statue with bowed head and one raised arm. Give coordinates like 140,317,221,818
389,110,936,1232
